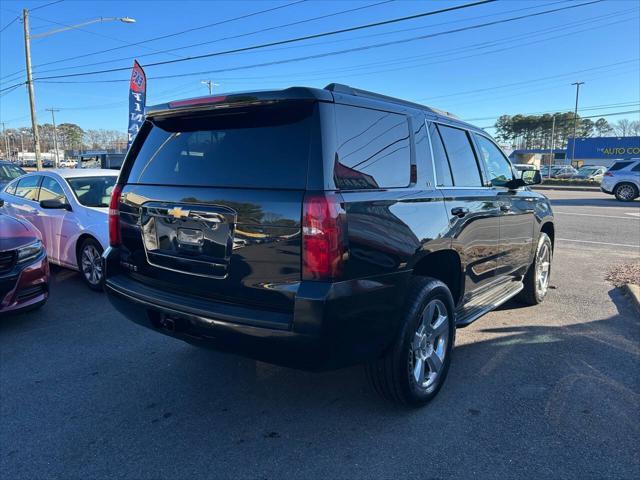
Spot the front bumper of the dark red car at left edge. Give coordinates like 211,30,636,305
0,252,49,314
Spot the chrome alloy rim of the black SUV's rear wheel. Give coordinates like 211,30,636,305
409,299,450,390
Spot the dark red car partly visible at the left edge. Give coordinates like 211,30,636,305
0,207,49,316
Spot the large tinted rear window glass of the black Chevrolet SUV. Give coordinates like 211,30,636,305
128,102,317,188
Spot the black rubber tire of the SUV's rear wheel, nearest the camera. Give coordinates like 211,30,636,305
366,277,455,406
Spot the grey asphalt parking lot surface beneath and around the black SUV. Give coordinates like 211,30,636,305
0,191,640,479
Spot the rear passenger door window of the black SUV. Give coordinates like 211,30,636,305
438,125,482,187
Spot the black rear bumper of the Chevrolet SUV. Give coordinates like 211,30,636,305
105,273,407,370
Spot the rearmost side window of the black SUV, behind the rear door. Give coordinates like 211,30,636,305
333,105,411,189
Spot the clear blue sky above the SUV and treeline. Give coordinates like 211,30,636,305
0,0,640,131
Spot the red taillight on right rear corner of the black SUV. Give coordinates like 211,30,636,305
302,193,346,280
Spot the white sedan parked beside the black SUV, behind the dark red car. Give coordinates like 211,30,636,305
0,169,118,290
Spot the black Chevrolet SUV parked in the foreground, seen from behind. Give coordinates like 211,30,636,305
103,84,554,405
